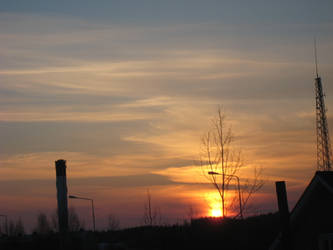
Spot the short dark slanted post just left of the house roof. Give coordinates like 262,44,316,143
275,181,291,249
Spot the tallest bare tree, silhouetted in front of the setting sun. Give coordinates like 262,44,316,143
200,106,263,217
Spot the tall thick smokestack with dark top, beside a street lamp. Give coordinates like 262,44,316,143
55,160,68,233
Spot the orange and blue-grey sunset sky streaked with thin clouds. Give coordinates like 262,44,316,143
0,0,333,230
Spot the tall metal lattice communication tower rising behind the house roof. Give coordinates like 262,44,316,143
314,40,332,171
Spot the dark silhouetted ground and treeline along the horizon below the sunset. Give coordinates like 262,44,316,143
0,214,279,250
